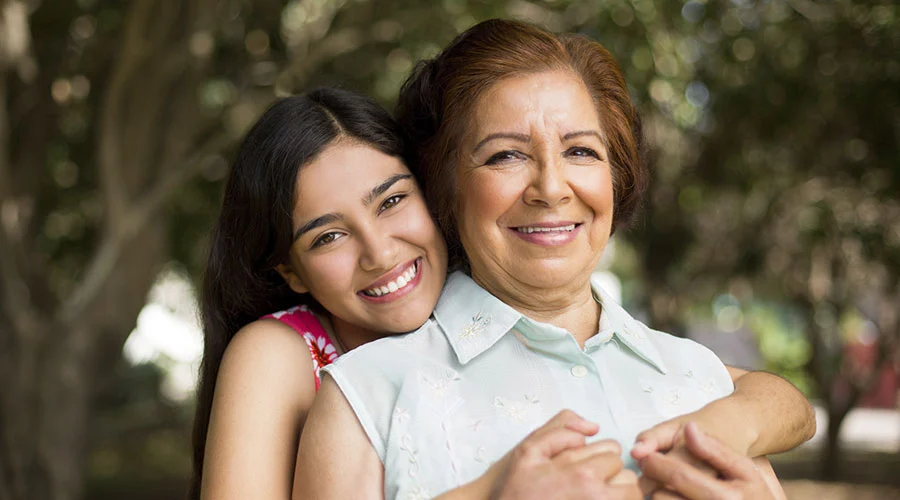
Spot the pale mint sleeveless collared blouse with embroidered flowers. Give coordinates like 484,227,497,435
323,273,734,499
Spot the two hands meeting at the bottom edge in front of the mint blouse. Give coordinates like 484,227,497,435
486,410,777,500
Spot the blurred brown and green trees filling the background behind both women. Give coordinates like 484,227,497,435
0,0,900,499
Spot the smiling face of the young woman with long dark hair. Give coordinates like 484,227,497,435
279,140,447,334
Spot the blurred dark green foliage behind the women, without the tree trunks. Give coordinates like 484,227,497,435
5,0,900,498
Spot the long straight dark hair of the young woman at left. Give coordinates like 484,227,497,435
189,88,402,499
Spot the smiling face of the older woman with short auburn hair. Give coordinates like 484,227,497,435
456,71,613,298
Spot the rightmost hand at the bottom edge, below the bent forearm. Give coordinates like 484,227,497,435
638,422,777,500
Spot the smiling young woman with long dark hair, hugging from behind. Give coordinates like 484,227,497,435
191,89,808,499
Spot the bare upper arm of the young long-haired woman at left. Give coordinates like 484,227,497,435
201,319,316,500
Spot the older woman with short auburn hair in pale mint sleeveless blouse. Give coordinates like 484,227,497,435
295,17,808,498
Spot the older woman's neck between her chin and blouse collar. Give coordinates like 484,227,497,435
472,273,600,347
